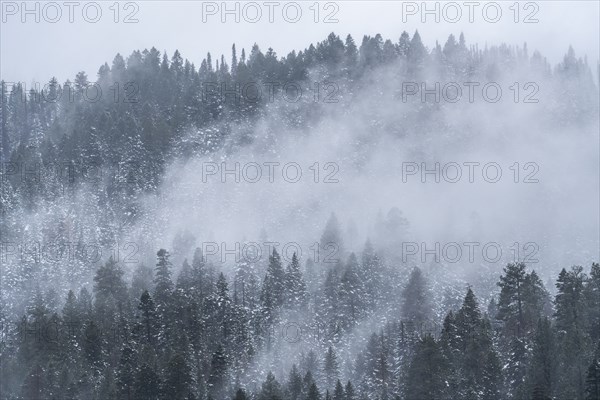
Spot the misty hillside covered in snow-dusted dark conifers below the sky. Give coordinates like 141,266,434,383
0,32,600,400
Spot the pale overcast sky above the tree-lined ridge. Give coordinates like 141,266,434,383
0,0,600,84
